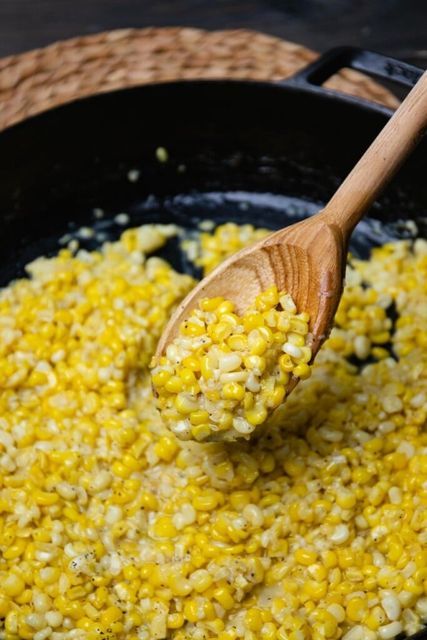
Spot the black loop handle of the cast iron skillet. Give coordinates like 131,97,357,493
286,47,423,92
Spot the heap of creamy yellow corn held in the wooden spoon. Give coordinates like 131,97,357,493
152,286,312,442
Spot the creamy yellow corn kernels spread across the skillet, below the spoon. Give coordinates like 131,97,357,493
0,227,427,640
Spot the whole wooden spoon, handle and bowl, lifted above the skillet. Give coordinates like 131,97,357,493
156,71,427,376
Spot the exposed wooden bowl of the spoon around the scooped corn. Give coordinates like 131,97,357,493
156,213,345,368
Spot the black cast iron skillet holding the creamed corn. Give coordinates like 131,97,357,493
0,48,427,640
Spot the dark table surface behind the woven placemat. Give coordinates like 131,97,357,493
0,0,427,66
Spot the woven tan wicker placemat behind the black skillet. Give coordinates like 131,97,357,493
0,28,398,129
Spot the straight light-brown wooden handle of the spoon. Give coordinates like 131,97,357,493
320,71,427,238
